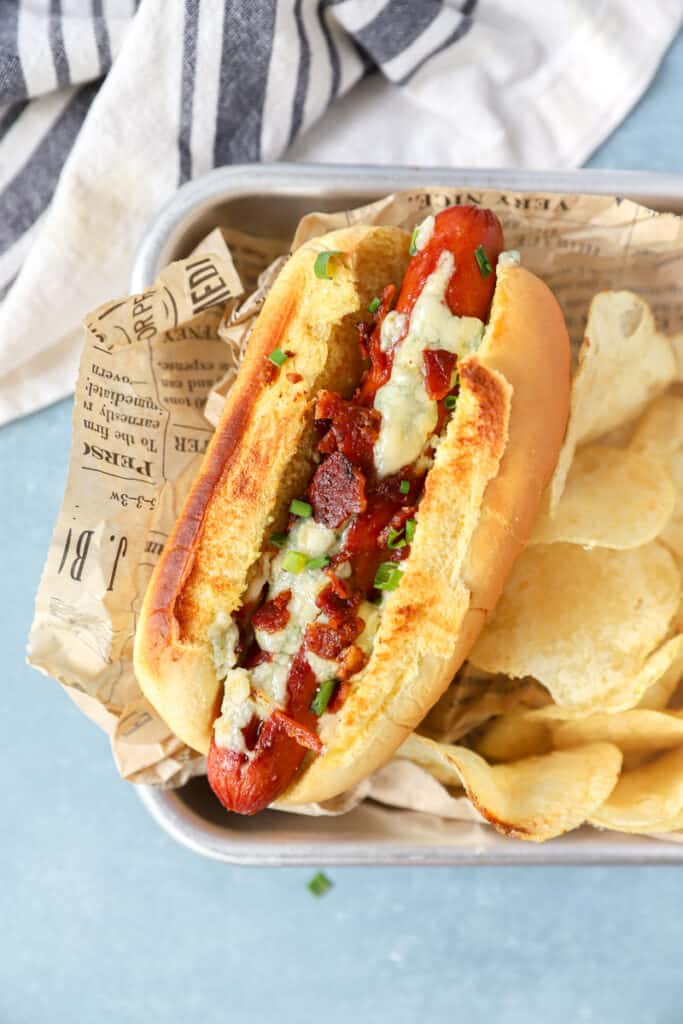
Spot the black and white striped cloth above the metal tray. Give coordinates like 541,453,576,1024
0,0,681,422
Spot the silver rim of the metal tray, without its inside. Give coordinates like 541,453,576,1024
130,163,683,867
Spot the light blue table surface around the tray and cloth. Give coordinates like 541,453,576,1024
0,29,683,1024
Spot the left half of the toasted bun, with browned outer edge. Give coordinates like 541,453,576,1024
134,225,410,753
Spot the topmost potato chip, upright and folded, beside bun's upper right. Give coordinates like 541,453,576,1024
550,292,676,512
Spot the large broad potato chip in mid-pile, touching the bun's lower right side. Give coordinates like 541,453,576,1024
470,541,681,712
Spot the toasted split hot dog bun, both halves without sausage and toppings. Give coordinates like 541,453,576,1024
135,227,569,806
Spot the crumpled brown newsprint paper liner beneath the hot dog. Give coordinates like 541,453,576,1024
29,188,683,821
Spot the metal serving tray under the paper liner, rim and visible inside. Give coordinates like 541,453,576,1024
131,164,683,865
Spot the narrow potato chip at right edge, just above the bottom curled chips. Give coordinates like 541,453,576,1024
552,708,683,754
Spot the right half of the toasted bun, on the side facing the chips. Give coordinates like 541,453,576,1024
279,266,570,806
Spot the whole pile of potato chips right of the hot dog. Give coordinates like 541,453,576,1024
398,292,683,842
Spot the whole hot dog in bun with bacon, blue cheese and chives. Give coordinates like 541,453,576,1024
135,207,569,814
